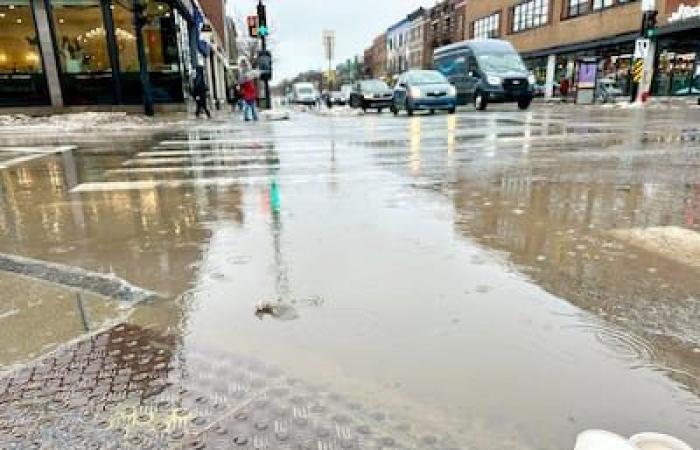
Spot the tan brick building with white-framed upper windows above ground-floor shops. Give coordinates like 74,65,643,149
466,0,700,96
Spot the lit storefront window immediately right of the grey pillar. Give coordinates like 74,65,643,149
51,0,114,104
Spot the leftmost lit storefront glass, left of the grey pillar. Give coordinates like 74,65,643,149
0,0,49,106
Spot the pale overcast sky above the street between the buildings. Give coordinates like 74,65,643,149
229,0,435,81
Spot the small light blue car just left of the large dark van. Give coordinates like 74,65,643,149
391,70,457,116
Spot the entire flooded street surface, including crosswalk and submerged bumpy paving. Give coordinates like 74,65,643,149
0,109,700,450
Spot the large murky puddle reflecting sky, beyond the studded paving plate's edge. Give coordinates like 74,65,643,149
0,112,700,450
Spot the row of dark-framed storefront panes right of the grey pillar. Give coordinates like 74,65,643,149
50,0,184,105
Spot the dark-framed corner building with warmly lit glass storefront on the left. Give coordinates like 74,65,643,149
0,0,228,110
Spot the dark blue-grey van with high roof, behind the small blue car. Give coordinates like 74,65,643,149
433,39,536,110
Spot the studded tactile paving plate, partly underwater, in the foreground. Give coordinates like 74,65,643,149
0,324,462,450
